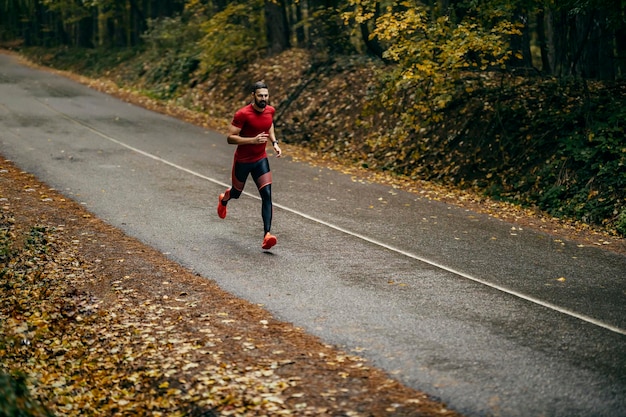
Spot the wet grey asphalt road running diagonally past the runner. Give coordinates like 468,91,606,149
0,55,626,417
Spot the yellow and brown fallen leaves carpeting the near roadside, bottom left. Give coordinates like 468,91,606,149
0,212,306,416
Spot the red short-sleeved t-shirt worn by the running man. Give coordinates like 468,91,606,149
231,104,276,162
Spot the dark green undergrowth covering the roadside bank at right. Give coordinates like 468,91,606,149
414,79,626,234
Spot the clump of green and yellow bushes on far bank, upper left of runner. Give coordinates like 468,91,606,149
111,0,265,100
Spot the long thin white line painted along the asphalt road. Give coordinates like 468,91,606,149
40,101,626,336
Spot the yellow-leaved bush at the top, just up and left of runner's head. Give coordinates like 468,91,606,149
200,0,267,74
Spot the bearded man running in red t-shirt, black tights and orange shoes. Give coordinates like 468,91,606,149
217,82,282,249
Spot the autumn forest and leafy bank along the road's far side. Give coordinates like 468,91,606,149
0,0,626,236
